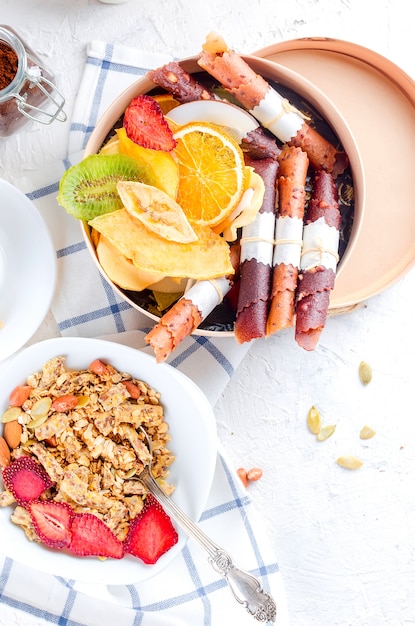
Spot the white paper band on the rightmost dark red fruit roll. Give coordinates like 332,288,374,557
300,217,340,272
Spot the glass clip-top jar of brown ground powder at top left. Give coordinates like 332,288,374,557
0,26,66,137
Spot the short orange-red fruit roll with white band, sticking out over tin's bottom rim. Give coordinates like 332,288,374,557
145,244,240,363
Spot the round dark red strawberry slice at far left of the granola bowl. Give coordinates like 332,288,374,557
3,456,53,505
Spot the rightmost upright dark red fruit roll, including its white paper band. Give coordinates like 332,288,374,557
295,171,342,350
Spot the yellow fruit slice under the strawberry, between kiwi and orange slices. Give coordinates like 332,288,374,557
117,128,179,198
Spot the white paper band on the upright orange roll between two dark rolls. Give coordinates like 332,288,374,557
273,216,304,268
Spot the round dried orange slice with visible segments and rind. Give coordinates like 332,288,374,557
173,122,245,226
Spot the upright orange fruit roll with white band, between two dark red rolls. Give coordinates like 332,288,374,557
267,144,309,335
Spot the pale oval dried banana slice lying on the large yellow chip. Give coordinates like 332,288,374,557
117,181,197,243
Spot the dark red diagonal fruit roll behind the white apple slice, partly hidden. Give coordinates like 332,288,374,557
147,61,279,159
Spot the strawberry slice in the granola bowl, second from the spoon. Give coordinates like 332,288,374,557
69,513,124,559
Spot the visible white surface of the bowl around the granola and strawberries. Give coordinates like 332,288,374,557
0,337,217,585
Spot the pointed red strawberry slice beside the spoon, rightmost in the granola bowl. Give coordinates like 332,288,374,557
124,494,179,565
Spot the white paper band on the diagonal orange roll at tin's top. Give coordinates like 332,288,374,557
250,87,304,142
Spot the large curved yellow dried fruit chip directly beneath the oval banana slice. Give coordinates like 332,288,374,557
90,209,234,280
